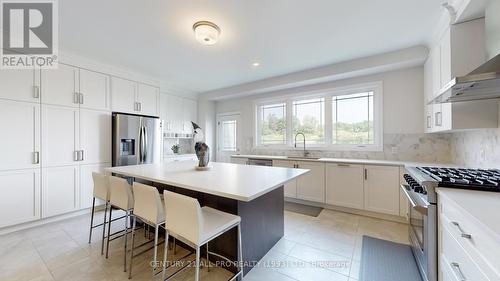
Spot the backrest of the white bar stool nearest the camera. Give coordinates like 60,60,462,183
163,190,203,245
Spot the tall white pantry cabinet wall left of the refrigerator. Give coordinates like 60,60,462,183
0,64,111,227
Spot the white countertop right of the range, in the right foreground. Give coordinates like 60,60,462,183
437,188,500,239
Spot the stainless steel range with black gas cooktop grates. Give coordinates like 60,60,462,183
401,167,500,281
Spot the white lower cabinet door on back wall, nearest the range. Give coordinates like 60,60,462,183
364,165,400,216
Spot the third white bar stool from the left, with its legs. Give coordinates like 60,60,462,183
128,182,168,279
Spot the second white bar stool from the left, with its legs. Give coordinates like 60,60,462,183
106,176,134,271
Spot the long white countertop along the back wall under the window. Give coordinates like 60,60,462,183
231,155,446,166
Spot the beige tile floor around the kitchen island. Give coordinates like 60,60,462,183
0,210,408,281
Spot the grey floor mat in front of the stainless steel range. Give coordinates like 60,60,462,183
359,236,422,281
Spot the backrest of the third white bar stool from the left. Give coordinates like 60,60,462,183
133,182,165,224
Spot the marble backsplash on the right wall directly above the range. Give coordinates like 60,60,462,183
450,129,500,169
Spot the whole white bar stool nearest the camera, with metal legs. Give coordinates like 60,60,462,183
163,190,243,281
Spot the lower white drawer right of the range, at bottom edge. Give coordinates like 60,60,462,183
440,224,488,281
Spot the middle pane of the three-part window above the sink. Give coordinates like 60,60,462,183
292,98,325,144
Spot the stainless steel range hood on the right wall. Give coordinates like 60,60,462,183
430,54,500,103
